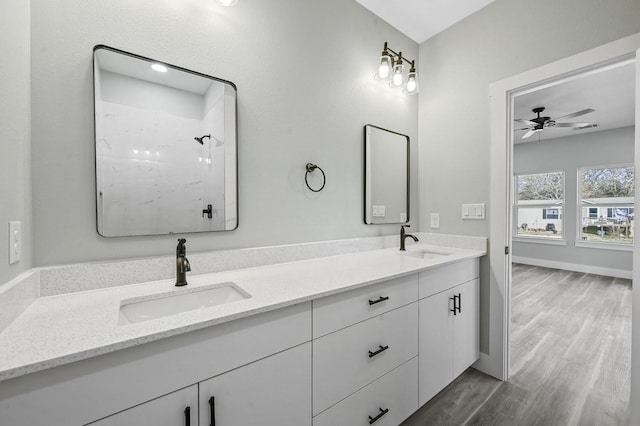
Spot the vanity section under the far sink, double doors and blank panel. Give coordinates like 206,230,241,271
419,260,480,405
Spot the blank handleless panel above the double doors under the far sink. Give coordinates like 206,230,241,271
419,259,480,299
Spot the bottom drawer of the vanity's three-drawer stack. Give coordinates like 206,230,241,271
313,358,418,426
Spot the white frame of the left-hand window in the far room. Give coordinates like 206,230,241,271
512,169,567,245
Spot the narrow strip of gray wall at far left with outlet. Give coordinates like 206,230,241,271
0,0,32,284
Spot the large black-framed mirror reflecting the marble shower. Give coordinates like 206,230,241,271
93,45,238,237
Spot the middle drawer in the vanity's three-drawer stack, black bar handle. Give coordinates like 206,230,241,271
313,302,418,415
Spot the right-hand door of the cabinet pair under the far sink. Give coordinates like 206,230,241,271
453,280,480,378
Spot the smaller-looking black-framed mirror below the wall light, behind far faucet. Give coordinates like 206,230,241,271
364,124,410,225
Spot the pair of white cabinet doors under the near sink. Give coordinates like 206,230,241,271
90,343,311,426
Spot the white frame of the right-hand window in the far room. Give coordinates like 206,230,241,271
575,163,635,251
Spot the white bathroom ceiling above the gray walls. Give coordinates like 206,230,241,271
356,0,494,43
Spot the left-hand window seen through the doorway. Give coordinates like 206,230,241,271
516,172,564,239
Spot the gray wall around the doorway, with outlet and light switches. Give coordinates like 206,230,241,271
418,0,640,352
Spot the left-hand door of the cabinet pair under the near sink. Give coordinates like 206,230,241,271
89,385,198,426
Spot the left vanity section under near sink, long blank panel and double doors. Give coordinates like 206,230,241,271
0,302,311,426
